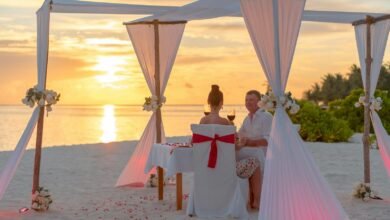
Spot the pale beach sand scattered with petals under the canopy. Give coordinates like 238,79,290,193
0,137,390,220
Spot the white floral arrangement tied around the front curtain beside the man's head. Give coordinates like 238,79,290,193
257,91,300,114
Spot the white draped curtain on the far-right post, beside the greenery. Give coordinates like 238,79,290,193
355,19,390,177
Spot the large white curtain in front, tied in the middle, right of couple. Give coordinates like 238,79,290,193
241,0,348,220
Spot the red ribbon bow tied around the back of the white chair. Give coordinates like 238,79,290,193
192,134,234,168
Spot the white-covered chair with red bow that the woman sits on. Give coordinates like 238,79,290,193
187,125,248,219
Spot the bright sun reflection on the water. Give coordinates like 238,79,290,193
100,105,116,143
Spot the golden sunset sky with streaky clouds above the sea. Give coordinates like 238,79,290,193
0,0,390,105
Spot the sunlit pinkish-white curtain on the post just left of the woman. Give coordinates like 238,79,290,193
116,23,185,186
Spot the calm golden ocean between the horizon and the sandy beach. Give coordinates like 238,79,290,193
0,105,247,151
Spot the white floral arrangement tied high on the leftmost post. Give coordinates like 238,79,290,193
22,86,60,112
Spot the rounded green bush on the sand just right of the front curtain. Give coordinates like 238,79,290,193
290,101,353,142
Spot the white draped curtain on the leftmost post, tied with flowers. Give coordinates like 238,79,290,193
0,1,50,200
